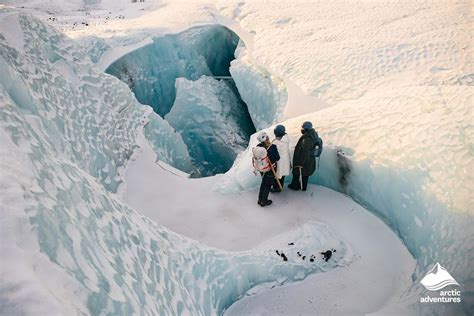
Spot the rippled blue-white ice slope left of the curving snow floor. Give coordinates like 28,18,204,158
0,9,350,315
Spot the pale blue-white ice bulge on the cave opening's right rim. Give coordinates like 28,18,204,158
229,45,288,129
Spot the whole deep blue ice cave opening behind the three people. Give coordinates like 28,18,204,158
106,25,255,177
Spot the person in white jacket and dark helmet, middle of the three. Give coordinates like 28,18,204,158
271,125,291,193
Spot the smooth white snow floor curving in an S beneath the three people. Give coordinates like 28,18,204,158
120,131,415,315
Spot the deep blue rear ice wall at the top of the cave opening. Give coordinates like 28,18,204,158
107,25,239,116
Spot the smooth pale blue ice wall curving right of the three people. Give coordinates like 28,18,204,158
310,146,474,315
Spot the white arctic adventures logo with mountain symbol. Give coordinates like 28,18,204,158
420,263,461,303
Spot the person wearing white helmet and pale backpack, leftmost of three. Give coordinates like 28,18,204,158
252,132,280,207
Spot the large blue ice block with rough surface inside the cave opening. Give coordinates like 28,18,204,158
165,76,255,176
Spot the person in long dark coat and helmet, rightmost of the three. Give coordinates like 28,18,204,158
288,122,323,191
